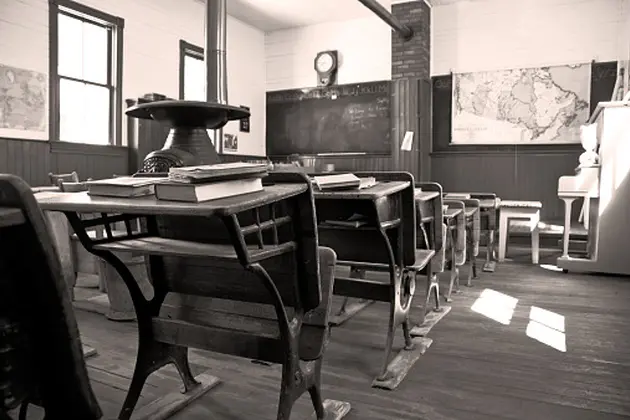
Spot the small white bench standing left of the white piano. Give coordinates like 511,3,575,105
499,200,542,264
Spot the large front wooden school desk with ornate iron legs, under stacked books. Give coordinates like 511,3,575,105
37,174,349,420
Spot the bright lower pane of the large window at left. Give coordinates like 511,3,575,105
59,79,110,144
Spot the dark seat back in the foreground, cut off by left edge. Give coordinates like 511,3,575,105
0,175,102,420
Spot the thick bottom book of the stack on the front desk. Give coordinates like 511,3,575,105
155,177,263,203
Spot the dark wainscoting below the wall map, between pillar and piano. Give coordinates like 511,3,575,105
431,145,582,220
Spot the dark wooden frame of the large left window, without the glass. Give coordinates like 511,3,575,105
48,0,125,146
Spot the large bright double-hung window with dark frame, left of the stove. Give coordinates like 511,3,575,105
49,0,124,145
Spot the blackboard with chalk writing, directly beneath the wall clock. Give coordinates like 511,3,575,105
267,81,391,156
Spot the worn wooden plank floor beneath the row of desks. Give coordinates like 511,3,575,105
53,253,630,420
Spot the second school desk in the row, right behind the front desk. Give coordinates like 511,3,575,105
315,171,435,384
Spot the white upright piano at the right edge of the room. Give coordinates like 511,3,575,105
557,101,630,275
